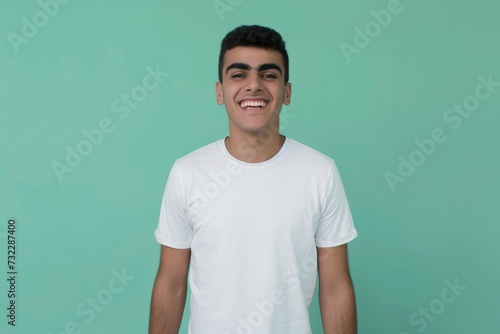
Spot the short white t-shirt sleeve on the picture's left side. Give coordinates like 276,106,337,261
154,161,193,249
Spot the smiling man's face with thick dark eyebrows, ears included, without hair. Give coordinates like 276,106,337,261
215,47,291,134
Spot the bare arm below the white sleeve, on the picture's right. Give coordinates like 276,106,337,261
317,244,357,334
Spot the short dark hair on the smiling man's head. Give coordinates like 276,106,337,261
219,25,289,83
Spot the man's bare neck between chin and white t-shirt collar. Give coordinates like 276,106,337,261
225,131,285,163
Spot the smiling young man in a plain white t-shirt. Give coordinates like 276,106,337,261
149,26,357,334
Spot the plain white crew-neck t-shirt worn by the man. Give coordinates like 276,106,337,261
154,137,357,334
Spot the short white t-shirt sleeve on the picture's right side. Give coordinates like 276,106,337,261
315,162,358,247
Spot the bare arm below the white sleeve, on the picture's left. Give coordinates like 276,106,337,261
149,245,191,334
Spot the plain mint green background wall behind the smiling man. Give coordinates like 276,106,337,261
0,0,500,334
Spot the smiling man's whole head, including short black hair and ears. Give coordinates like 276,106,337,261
215,26,292,136
